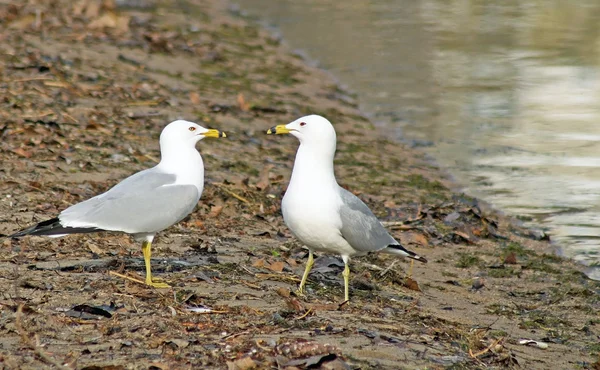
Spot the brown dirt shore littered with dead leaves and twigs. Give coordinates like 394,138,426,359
0,0,600,370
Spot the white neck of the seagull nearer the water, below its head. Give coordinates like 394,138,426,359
290,144,337,188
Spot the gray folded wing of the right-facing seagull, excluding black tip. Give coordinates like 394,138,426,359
59,170,200,234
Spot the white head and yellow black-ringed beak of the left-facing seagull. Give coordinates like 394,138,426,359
267,114,336,148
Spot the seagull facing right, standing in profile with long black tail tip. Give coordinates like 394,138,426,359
8,120,226,288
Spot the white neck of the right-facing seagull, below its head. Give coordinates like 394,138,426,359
157,147,204,194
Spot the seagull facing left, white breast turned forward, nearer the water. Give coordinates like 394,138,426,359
267,115,427,302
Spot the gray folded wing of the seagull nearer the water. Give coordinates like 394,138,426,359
340,187,398,252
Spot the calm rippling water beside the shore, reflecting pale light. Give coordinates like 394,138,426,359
238,0,600,278
